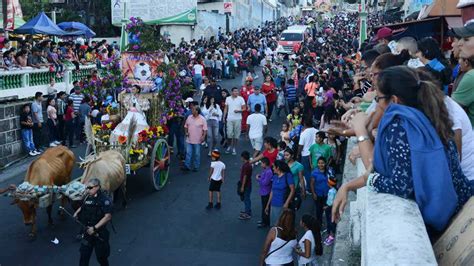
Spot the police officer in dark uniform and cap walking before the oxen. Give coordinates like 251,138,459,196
74,178,112,266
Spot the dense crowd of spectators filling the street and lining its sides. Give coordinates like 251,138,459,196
4,9,474,265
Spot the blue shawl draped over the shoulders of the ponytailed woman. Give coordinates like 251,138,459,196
374,104,458,231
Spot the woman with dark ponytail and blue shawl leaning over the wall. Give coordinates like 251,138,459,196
332,66,473,232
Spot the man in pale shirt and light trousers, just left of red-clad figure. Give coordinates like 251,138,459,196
223,87,245,155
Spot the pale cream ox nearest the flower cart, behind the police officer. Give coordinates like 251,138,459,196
81,150,127,205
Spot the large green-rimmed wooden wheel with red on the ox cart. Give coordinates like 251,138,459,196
150,139,171,190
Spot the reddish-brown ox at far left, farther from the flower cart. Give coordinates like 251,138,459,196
14,146,75,237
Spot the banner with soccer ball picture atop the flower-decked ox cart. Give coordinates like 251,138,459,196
121,52,164,92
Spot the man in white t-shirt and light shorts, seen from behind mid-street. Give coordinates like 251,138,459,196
247,104,267,158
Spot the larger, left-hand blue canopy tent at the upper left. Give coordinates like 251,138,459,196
14,12,80,36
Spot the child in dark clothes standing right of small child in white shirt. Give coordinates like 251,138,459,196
239,151,252,220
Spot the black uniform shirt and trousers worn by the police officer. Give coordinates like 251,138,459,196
79,191,112,266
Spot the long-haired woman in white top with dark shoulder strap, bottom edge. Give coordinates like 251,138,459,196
259,209,297,266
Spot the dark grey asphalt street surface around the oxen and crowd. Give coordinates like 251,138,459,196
0,69,331,266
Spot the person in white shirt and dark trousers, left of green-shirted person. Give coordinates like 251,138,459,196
298,118,318,191
